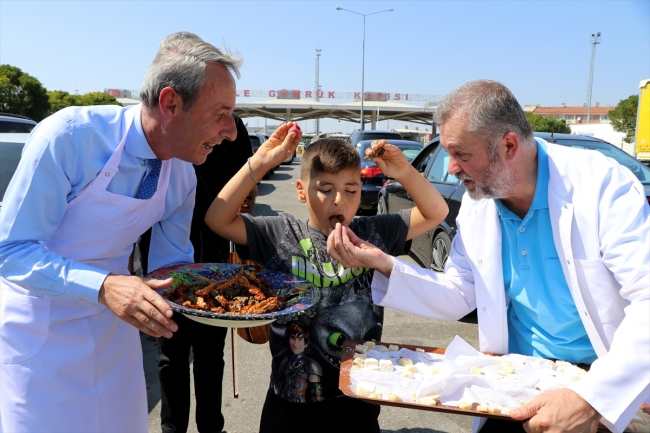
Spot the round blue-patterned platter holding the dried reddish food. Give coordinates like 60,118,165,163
146,263,320,328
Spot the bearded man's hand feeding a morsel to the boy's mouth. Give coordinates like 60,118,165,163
327,223,393,276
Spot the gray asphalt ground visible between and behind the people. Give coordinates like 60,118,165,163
141,155,478,433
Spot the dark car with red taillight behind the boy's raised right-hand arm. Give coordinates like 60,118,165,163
354,140,424,212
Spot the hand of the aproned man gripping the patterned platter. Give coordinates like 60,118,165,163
98,275,178,338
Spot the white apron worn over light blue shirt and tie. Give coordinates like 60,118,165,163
0,114,171,433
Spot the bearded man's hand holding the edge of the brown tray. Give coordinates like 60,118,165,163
510,389,601,433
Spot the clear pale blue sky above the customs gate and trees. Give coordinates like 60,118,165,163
0,0,650,132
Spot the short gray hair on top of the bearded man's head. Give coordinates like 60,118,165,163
434,80,535,146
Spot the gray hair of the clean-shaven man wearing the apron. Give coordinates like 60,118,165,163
140,32,242,112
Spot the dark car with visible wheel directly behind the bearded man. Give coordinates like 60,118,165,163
377,132,650,272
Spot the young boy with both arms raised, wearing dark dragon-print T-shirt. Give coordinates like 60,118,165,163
205,123,448,433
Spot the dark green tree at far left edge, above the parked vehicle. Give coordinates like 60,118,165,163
0,65,50,122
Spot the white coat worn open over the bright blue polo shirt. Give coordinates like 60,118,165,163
373,144,650,432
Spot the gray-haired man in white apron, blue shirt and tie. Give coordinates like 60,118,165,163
0,33,241,433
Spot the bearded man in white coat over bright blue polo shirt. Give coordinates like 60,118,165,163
328,80,650,432
